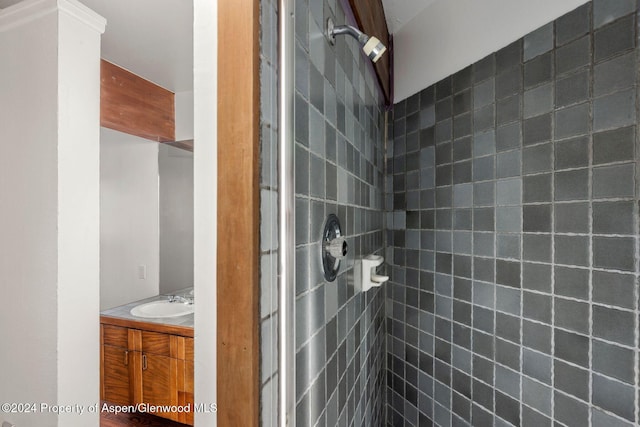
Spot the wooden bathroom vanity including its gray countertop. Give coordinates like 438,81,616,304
100,296,194,425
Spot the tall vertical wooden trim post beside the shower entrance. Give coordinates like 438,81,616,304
218,0,260,427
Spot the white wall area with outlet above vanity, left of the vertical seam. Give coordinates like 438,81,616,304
100,128,160,310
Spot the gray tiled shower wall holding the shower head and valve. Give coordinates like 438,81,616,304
260,0,385,427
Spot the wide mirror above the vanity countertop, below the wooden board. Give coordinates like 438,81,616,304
100,128,193,310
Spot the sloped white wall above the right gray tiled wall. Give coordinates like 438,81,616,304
393,0,587,102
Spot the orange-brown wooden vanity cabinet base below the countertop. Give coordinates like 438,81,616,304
101,322,193,425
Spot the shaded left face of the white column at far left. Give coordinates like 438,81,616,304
0,5,58,425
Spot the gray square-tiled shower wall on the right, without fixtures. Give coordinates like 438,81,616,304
385,0,640,426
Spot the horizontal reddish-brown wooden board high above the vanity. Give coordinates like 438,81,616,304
100,60,176,142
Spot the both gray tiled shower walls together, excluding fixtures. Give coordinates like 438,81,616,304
261,0,640,426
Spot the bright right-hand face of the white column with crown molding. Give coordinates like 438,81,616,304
57,1,105,427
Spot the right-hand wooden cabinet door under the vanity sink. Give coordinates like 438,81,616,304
142,353,178,420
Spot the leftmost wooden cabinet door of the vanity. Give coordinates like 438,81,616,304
100,325,133,405
